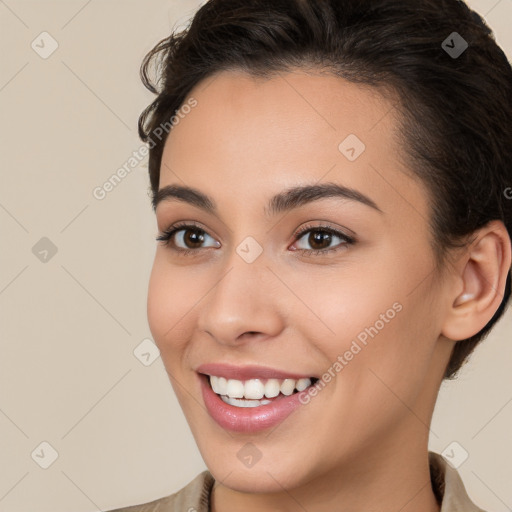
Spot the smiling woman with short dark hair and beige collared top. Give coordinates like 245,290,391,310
109,0,512,512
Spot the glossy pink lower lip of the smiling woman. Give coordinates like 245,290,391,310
199,374,312,432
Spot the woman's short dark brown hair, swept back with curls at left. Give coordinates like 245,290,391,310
139,0,512,379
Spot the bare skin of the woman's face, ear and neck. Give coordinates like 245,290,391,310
148,70,511,512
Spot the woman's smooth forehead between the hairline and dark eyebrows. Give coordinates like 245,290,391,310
160,70,428,228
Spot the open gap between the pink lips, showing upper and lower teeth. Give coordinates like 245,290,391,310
202,374,319,407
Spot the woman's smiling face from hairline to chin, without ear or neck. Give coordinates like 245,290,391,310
148,71,452,492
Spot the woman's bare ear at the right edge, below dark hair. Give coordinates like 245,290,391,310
441,220,512,341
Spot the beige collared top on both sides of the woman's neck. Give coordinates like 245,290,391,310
108,451,485,512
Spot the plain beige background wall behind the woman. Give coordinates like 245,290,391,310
0,0,512,512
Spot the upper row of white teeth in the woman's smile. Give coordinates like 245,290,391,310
210,375,311,400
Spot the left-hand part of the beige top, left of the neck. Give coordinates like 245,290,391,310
106,470,215,512
